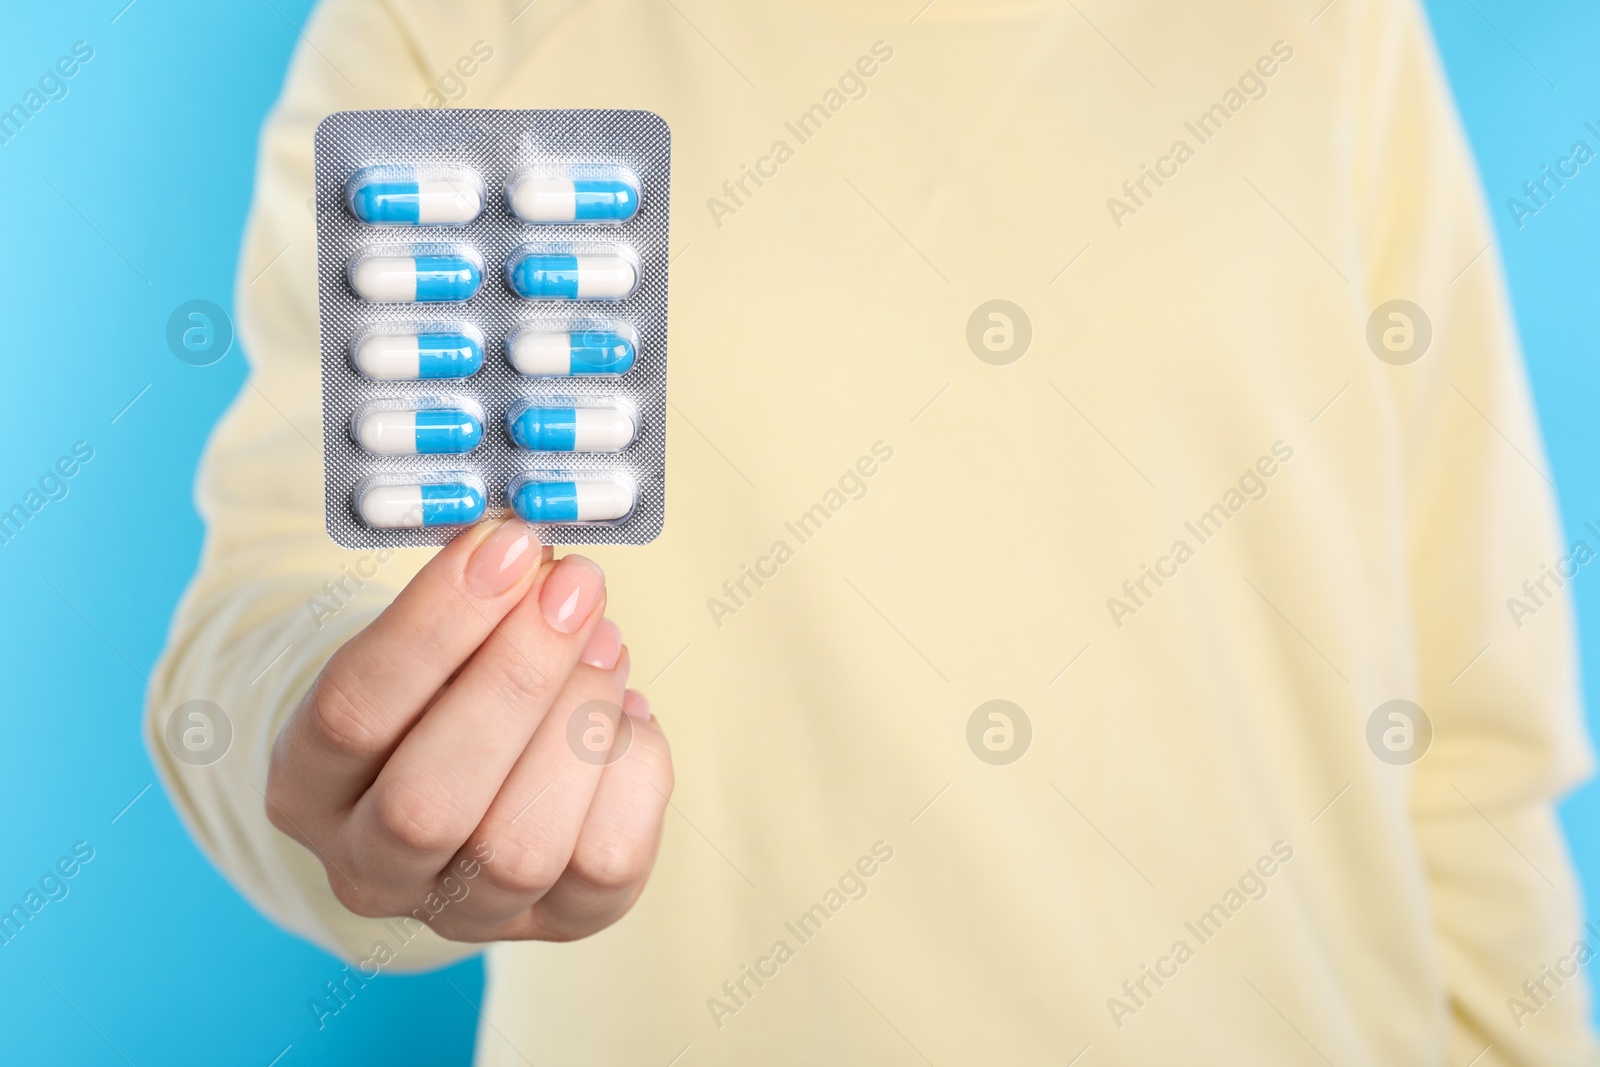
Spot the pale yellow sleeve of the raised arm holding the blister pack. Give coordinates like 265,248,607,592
144,0,533,969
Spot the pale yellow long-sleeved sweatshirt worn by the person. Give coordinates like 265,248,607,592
149,0,1600,1067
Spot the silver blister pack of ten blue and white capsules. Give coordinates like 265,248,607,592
315,109,672,549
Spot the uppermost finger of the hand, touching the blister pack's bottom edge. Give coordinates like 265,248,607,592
267,518,549,816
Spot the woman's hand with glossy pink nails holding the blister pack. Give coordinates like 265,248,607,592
266,520,672,941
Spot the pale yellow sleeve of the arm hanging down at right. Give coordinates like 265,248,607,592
1347,0,1600,1067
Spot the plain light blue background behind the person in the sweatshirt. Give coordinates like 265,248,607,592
0,0,1600,1067
